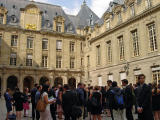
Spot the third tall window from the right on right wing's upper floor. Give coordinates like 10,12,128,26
118,36,124,60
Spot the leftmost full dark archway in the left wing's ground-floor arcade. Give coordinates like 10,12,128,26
7,75,18,90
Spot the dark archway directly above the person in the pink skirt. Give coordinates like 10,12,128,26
23,76,34,91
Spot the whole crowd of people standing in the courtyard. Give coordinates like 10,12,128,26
4,74,160,120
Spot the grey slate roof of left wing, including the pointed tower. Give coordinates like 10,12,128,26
0,0,99,33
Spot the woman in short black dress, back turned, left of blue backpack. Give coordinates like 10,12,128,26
91,86,102,120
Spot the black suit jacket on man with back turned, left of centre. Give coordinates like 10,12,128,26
62,90,77,114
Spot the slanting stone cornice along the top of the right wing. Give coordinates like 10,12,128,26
89,4,160,43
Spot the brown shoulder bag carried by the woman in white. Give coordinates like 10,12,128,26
36,97,46,112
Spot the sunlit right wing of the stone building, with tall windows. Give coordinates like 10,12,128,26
84,0,160,86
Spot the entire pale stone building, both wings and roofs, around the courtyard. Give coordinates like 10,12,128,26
0,0,160,93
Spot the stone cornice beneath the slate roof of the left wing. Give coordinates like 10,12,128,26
0,25,85,40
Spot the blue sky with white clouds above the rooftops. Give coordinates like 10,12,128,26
34,0,112,17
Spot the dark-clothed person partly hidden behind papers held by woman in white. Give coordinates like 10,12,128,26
48,87,56,120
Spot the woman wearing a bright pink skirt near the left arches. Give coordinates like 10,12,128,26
23,88,29,117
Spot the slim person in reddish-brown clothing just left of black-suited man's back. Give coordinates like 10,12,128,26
57,86,63,119
